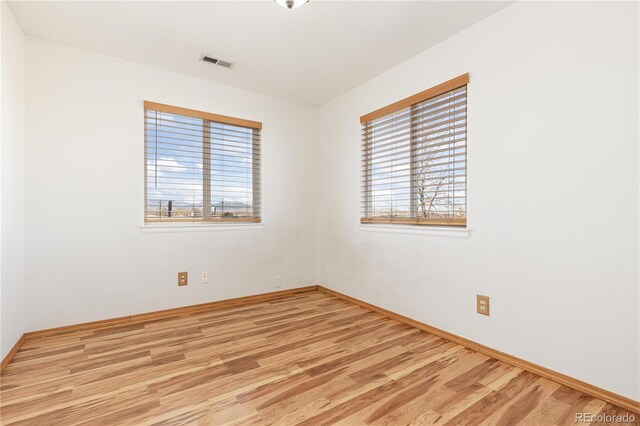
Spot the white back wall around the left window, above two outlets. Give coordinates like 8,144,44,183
27,38,316,330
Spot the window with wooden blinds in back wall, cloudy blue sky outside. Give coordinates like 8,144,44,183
144,101,262,223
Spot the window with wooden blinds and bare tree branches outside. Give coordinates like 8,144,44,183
360,74,469,226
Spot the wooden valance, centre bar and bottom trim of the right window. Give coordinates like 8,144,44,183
360,73,469,228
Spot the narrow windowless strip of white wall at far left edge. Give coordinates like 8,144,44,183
0,1,26,358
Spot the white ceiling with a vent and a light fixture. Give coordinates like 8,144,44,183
10,0,511,105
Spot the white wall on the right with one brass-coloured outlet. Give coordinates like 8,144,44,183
318,2,640,400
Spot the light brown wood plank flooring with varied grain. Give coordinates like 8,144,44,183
0,291,639,426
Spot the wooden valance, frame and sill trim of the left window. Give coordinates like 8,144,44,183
143,101,262,228
